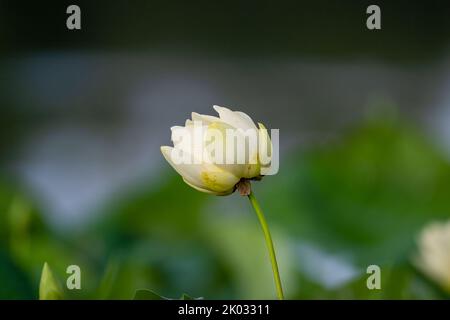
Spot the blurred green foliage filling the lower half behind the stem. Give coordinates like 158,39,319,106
0,117,450,299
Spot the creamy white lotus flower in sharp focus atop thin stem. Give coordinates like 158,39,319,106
161,106,273,195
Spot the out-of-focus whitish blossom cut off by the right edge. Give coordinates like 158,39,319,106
416,220,450,292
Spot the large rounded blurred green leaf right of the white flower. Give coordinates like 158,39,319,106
260,119,450,267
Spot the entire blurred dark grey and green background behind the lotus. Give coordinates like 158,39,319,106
0,0,450,299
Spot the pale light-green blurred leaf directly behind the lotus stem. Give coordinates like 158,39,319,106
203,212,298,299
